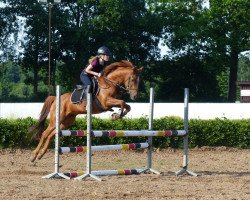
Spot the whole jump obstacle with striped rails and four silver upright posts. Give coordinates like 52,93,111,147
42,86,197,181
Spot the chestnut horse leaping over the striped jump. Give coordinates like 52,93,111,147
30,60,143,162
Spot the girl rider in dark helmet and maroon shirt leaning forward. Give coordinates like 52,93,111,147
80,46,111,93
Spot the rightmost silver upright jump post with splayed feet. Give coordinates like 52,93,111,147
175,88,198,176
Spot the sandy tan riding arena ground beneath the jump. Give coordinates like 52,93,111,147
0,147,250,200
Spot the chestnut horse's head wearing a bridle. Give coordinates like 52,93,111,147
124,67,143,100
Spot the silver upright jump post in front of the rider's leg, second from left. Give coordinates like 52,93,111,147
75,90,102,181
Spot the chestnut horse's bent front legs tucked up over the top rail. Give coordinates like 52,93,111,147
106,98,131,120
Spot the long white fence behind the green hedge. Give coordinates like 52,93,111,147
0,103,250,119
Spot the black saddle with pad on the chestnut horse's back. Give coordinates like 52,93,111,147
70,78,100,104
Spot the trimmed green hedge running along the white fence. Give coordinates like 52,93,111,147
0,117,250,148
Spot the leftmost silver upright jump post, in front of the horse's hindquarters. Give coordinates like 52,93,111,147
42,85,70,179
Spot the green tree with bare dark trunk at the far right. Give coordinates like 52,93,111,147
209,0,250,102
